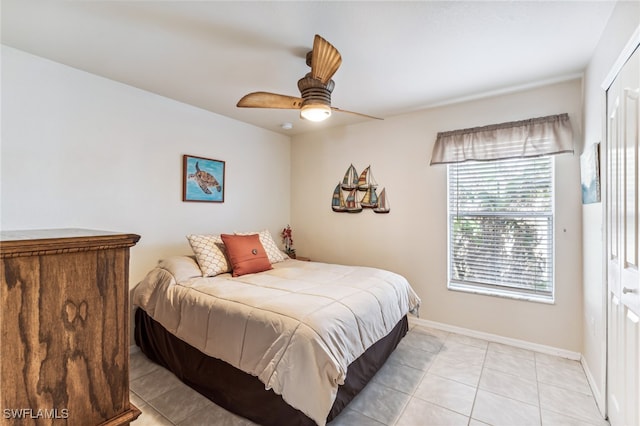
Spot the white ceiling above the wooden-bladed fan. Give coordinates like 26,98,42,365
1,0,615,134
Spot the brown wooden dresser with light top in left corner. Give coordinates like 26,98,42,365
0,229,140,426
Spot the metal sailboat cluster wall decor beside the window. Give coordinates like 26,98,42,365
331,164,391,213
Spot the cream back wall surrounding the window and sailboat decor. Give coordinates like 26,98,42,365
291,79,582,352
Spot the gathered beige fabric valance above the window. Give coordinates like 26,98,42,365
431,113,573,164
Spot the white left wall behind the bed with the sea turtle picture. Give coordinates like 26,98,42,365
0,46,290,285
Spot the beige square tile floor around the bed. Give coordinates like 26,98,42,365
130,326,608,426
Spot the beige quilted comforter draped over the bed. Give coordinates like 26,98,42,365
133,257,420,425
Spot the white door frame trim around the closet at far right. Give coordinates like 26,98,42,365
597,25,640,418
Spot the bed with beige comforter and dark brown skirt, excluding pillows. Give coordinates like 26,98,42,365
133,233,420,426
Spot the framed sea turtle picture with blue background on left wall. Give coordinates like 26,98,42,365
182,155,224,203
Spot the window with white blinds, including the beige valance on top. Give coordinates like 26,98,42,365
431,113,573,302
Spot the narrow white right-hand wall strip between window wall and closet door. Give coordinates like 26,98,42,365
580,2,640,410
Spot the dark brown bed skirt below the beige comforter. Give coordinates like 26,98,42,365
135,308,409,426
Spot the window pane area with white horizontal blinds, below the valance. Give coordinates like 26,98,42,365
447,155,554,301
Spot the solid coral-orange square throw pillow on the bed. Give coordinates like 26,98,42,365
220,234,271,277
